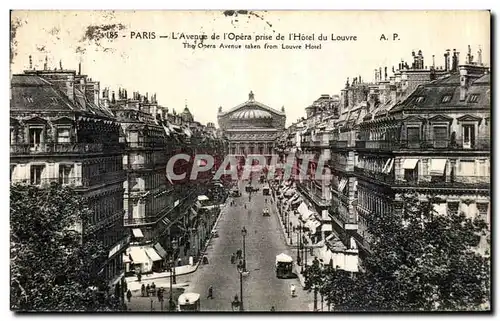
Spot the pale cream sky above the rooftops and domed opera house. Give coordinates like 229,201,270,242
11,11,490,125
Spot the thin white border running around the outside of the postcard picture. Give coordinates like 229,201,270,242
0,0,500,320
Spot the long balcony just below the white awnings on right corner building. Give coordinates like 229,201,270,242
394,175,491,189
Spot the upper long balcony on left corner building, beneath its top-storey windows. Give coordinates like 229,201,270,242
10,143,123,155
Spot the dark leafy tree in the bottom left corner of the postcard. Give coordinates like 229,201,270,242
10,184,119,311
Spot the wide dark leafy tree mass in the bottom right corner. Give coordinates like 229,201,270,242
302,194,490,311
